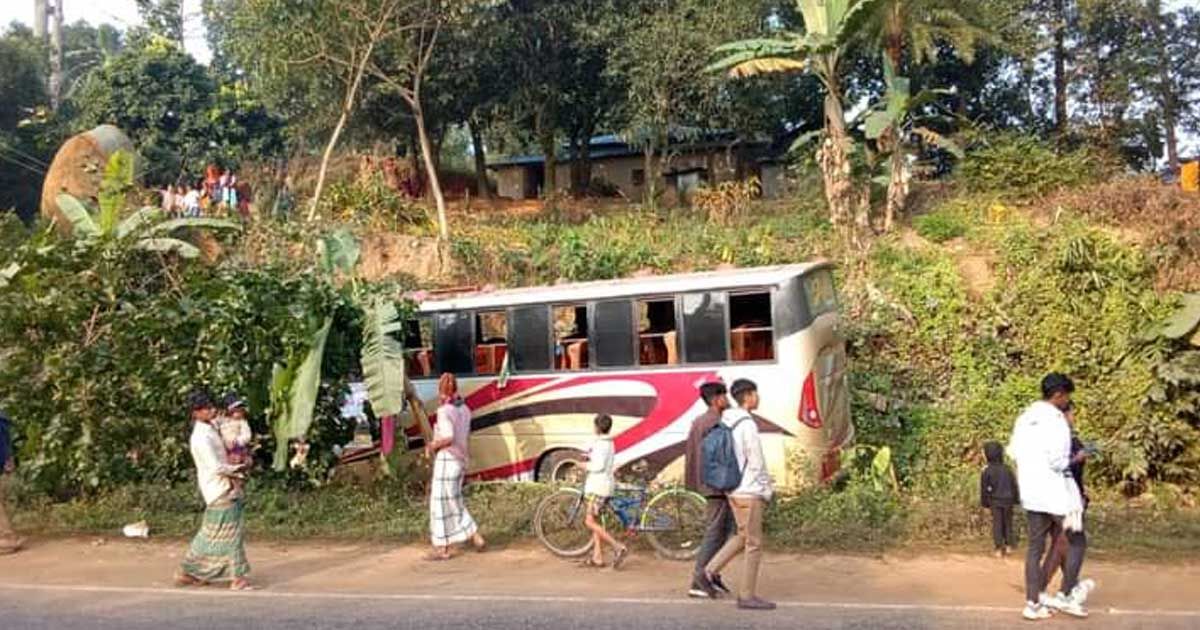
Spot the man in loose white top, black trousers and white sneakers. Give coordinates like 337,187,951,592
1008,373,1087,620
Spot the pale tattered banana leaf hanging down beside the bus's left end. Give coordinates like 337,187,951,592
360,299,407,418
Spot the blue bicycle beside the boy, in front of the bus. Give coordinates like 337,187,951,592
533,484,706,560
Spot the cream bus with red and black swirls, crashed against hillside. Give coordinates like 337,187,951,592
360,262,853,486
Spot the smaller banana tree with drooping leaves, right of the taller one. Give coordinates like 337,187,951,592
863,56,962,230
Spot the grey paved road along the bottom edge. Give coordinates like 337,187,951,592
0,583,1200,630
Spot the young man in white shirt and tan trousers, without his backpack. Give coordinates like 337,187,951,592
702,379,775,611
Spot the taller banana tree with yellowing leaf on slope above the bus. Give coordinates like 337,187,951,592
709,0,881,245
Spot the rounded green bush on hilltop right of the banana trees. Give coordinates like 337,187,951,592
958,133,1116,198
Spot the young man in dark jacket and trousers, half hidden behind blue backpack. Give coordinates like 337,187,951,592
684,383,737,599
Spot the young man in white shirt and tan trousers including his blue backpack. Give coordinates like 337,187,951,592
698,379,775,611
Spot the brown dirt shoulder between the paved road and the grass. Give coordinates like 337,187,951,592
0,539,1200,612
